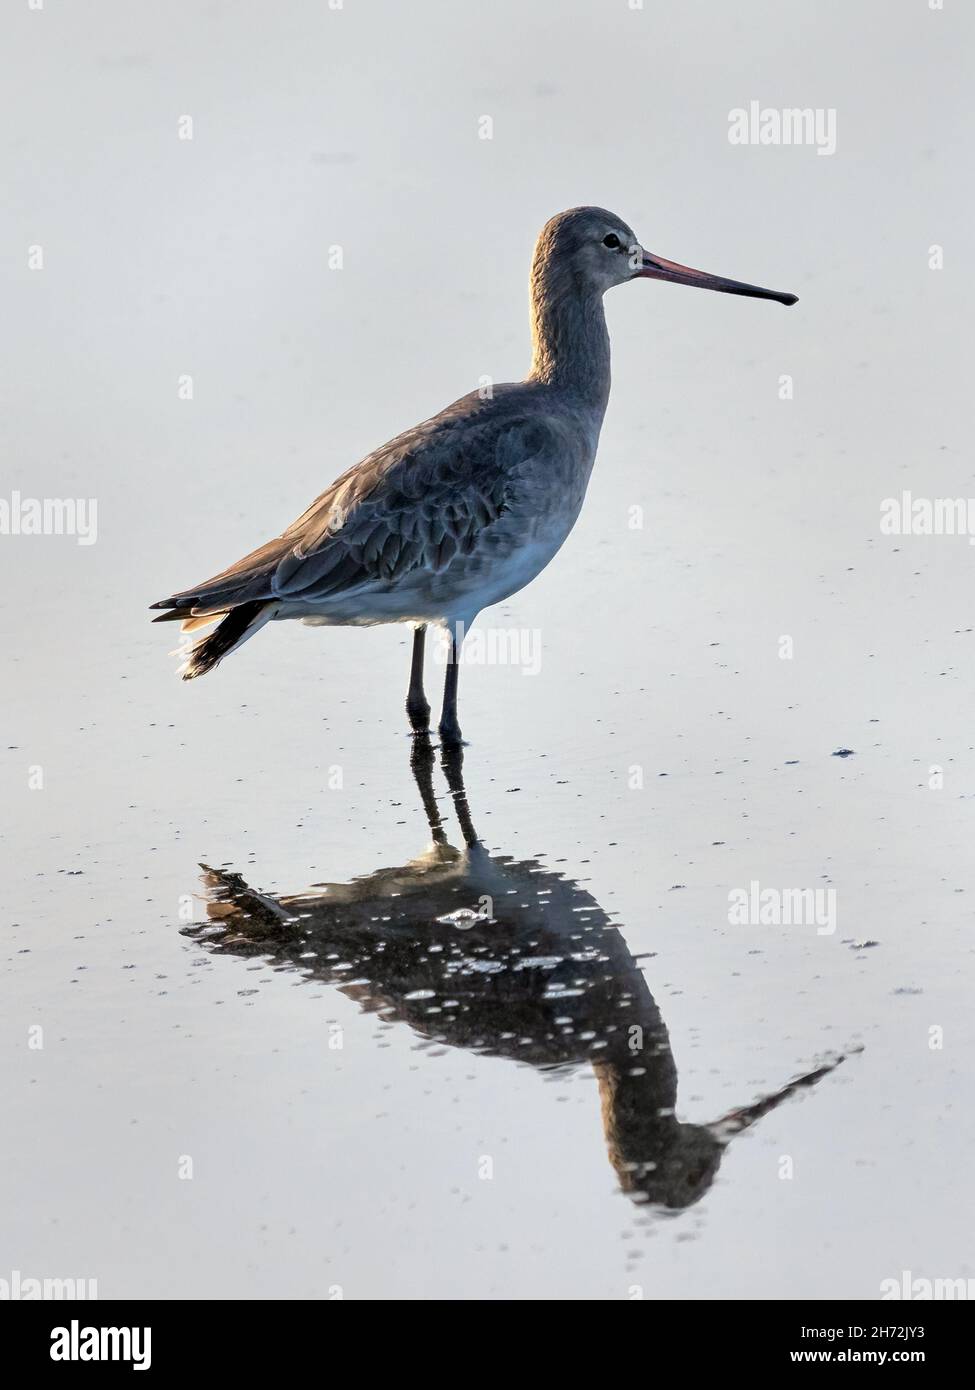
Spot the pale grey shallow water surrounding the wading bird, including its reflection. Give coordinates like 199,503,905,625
0,0,975,1298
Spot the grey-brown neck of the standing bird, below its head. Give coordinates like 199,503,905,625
529,263,609,413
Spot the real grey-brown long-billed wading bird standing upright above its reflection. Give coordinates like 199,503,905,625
152,207,797,745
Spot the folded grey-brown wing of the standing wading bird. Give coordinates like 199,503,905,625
156,411,555,612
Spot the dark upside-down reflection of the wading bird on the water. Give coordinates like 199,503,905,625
185,739,843,1209
